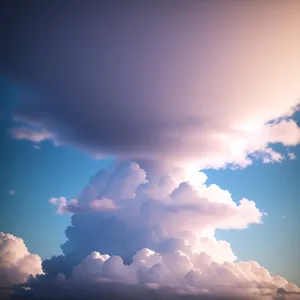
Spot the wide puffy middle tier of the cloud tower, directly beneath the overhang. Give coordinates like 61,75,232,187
49,162,263,236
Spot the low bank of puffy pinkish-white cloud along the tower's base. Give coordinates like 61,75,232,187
68,249,300,299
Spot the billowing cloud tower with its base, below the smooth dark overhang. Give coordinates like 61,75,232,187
11,162,300,299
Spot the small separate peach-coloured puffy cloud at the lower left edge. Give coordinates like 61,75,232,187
0,232,42,288
